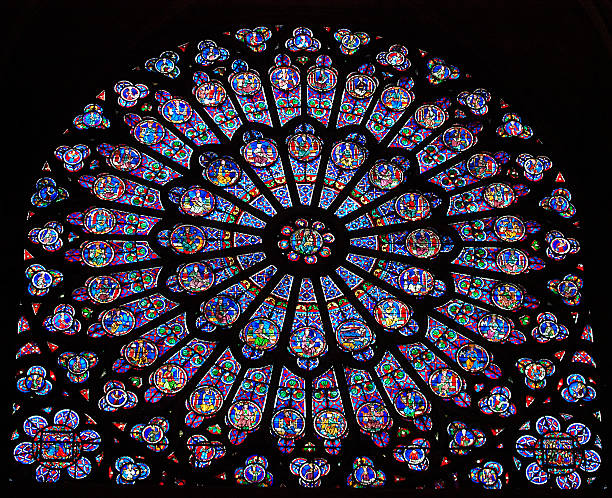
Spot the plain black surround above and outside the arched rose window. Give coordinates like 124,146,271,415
5,0,612,496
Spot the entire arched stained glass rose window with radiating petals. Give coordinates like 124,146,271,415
10,26,603,490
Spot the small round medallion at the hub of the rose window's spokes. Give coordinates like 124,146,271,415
278,218,335,264
